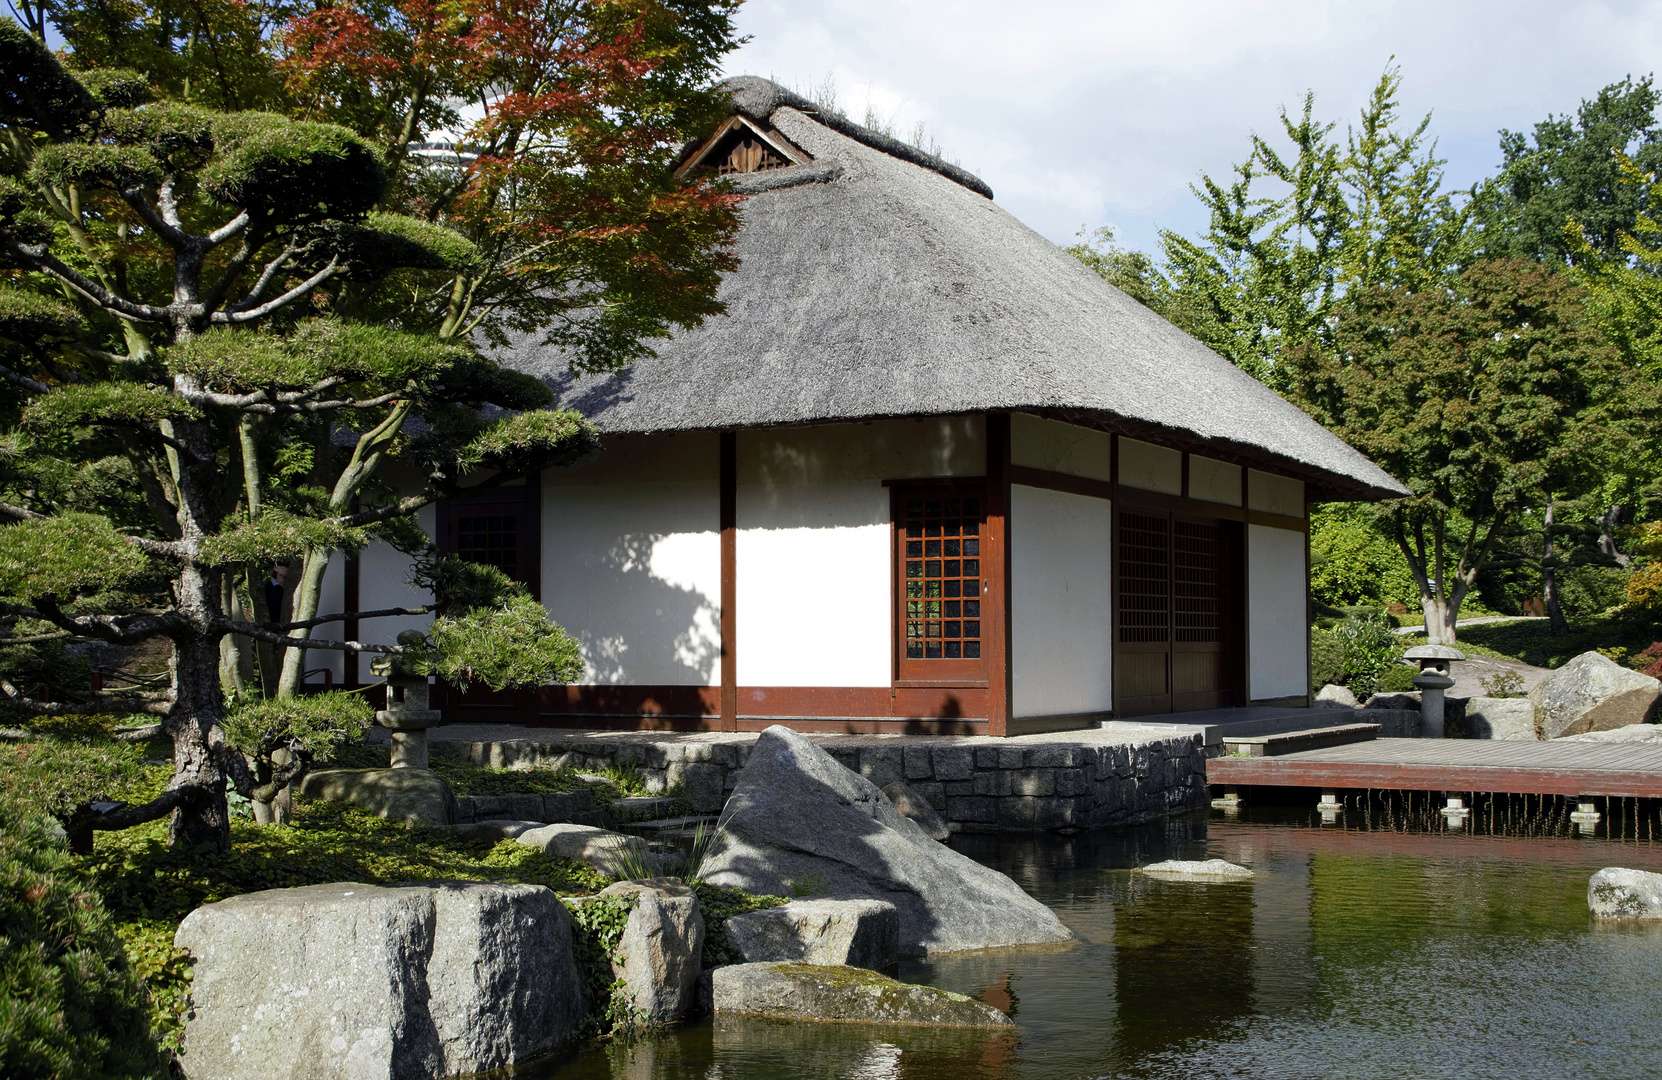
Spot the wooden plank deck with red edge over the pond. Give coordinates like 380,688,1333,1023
1207,739,1662,799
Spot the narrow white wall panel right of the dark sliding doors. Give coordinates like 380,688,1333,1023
1247,525,1310,700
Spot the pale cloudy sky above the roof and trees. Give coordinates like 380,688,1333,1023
726,0,1662,253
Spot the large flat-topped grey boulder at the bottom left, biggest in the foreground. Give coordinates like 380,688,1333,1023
175,884,585,1080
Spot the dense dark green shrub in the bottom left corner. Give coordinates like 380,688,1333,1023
0,787,165,1080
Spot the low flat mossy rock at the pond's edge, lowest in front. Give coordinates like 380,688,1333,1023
711,964,1010,1027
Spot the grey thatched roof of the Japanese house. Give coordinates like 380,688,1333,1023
504,78,1404,498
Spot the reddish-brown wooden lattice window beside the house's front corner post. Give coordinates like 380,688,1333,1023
894,485,991,680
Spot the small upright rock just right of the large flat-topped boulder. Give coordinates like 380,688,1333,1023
597,877,705,1024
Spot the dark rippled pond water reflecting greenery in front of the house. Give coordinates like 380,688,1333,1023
517,801,1662,1080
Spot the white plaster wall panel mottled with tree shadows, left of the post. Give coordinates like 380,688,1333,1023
542,434,721,686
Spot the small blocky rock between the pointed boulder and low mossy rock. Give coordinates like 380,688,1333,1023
725,901,901,970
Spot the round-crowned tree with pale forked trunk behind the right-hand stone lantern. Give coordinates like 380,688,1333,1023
1285,259,1657,643
